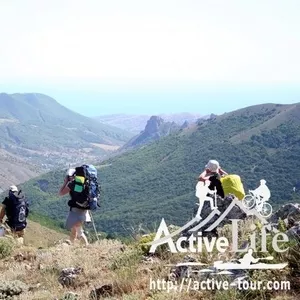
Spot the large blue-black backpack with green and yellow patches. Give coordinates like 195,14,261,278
71,165,100,210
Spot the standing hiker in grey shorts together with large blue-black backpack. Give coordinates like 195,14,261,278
59,165,100,245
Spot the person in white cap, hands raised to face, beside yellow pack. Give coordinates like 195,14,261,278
198,160,228,198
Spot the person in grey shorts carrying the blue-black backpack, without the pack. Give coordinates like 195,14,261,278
59,169,89,245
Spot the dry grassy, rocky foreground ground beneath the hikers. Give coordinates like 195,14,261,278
0,204,300,300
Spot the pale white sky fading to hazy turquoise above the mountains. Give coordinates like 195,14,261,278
0,0,300,116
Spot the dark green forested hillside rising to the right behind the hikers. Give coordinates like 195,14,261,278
19,104,300,235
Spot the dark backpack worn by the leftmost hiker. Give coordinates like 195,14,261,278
6,191,29,231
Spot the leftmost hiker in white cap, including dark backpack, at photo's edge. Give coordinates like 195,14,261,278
0,185,29,243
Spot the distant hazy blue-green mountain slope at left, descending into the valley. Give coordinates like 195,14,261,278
0,93,132,167
